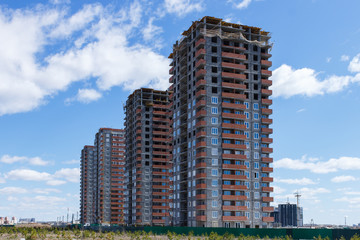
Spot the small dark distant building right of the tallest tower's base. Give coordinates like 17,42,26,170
273,203,303,227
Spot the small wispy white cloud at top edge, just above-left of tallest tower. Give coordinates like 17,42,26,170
164,0,204,16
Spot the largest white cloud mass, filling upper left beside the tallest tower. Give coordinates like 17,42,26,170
0,1,170,116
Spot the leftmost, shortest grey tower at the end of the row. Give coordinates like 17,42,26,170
80,145,96,223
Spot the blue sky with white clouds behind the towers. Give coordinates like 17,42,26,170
0,0,360,224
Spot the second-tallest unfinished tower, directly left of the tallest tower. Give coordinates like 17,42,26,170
125,88,172,225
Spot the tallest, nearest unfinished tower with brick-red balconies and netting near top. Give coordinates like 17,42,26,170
169,17,273,228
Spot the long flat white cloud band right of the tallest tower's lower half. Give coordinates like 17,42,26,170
274,156,360,173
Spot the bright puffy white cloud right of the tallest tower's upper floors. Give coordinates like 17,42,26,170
271,64,360,98
